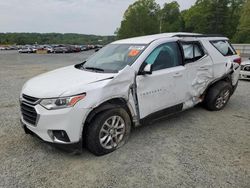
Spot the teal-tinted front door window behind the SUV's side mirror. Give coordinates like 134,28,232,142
145,42,182,71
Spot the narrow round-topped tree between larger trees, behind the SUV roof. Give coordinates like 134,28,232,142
160,1,183,32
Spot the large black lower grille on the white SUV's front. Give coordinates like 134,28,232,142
21,102,37,125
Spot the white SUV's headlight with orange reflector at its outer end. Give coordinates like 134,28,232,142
40,94,86,110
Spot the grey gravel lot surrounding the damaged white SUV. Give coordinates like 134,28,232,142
0,52,250,188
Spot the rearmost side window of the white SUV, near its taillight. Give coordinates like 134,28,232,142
210,40,236,56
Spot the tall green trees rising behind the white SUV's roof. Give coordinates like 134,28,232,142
115,0,250,43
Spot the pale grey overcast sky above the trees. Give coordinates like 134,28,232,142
0,0,196,35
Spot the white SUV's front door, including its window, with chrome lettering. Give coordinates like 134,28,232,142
136,42,187,119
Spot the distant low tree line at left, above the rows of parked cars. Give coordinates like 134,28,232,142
0,33,114,45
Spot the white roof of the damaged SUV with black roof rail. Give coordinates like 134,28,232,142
113,32,228,44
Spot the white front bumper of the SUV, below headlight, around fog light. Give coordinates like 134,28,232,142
21,104,89,145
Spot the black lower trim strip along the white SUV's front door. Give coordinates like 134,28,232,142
140,103,183,124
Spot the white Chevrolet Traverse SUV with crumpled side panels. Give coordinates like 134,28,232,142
20,33,241,155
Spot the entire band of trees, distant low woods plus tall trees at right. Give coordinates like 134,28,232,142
0,0,250,45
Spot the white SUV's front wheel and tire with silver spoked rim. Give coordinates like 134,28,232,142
86,108,131,156
